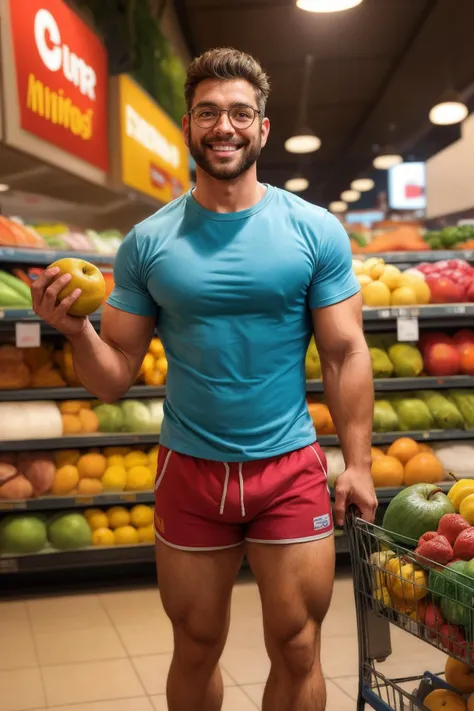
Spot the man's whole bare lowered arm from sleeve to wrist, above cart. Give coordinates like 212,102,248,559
312,294,374,472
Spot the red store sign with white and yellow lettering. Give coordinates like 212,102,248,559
10,0,108,171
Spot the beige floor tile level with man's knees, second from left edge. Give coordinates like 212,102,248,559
35,625,127,666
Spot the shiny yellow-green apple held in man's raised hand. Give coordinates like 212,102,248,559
49,257,105,316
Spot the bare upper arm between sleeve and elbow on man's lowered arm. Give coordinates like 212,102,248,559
311,293,365,358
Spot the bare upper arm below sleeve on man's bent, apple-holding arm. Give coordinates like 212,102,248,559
100,304,156,373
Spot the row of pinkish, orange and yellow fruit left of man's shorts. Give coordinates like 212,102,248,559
0,446,158,501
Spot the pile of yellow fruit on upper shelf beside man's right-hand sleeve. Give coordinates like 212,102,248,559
352,257,431,308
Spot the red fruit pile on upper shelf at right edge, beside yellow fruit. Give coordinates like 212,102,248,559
417,259,474,304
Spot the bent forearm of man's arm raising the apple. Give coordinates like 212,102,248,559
68,323,130,402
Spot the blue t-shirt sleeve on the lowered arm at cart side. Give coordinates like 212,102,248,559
308,212,360,309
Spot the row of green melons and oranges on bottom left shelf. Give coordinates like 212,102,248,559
0,504,155,555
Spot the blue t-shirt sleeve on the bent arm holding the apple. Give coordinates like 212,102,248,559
107,228,158,316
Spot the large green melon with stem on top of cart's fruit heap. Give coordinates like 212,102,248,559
383,484,455,547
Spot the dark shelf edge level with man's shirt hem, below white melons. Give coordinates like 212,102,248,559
0,430,474,452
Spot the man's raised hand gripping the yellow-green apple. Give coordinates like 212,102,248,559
31,267,88,336
